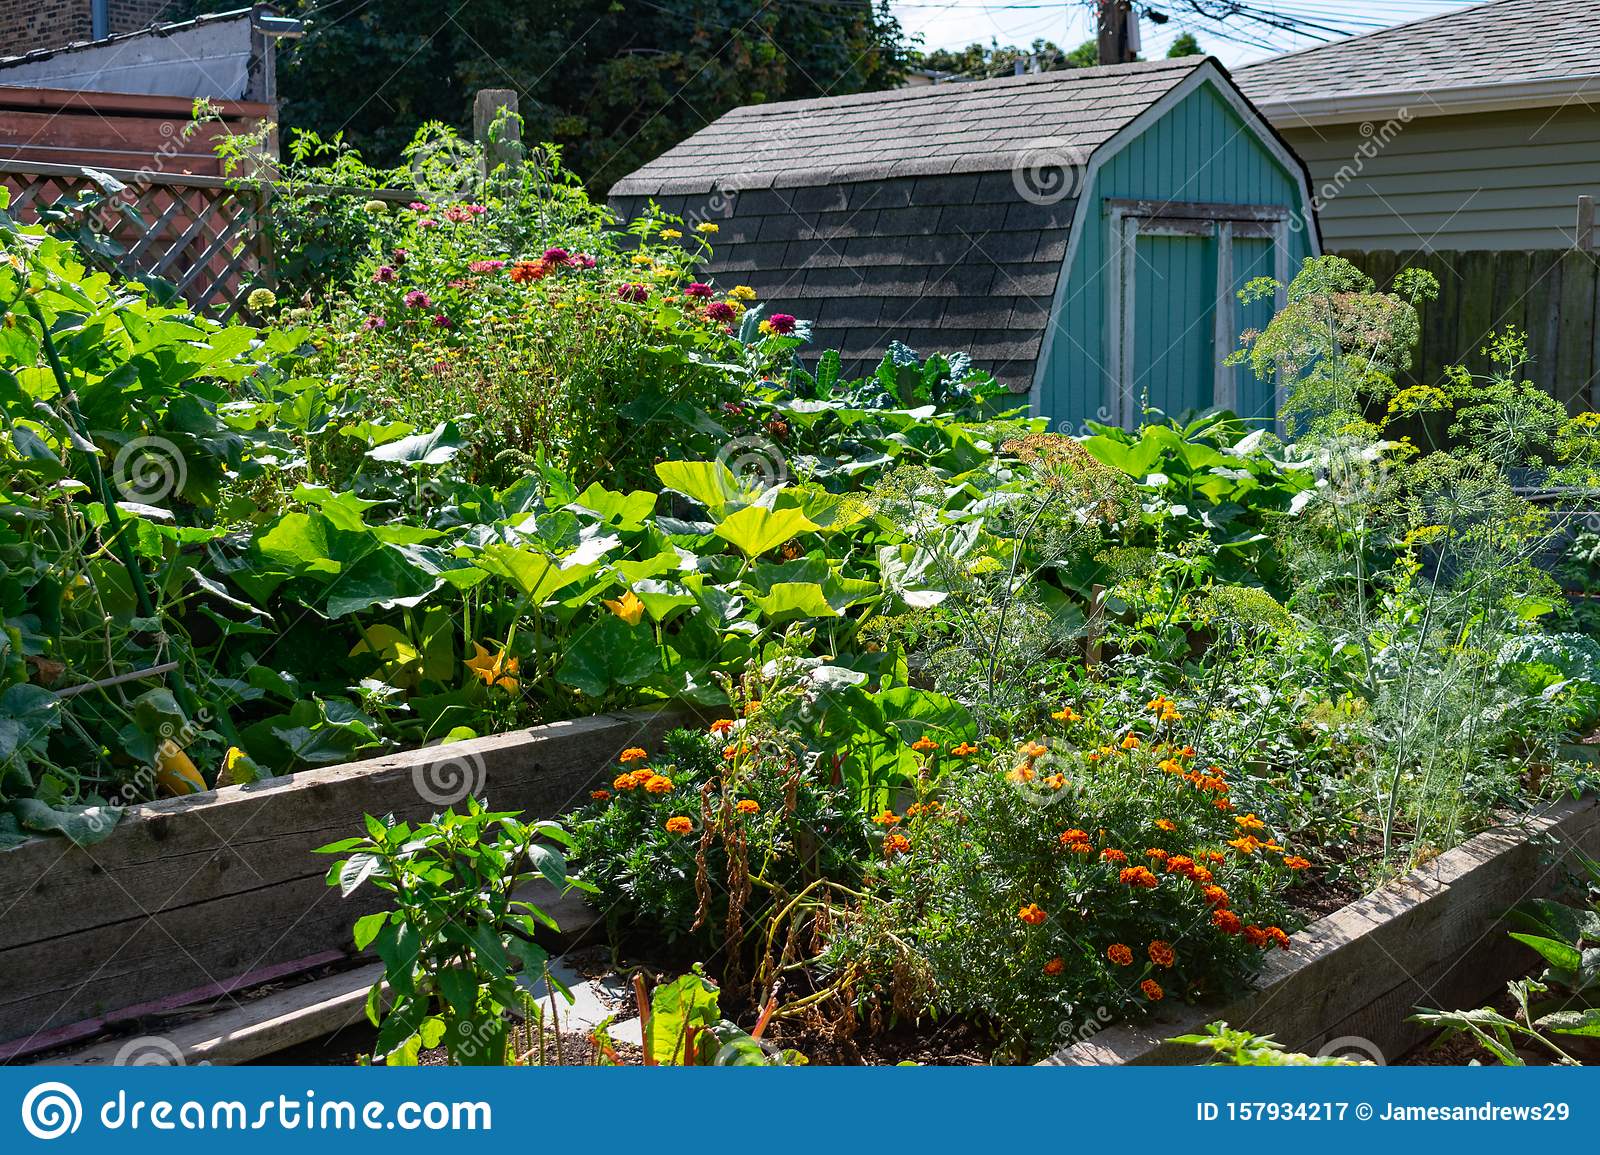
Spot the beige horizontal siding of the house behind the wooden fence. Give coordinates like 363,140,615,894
1278,104,1600,253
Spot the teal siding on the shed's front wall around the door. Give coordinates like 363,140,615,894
1038,83,1314,434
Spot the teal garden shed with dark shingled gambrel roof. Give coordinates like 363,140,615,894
611,58,1318,430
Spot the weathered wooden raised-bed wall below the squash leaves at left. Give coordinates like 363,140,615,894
0,710,693,1049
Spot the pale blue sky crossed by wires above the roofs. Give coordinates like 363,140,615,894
893,0,1464,66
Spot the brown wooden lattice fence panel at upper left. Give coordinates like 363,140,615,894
0,165,270,320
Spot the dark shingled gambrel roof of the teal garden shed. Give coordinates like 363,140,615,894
611,58,1227,389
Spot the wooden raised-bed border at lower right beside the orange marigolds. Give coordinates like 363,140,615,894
1042,797,1600,1065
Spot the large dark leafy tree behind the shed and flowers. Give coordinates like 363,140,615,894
173,0,907,194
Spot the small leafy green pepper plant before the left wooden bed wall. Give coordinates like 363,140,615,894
317,798,581,1065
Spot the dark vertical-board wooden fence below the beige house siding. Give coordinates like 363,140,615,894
1338,248,1600,411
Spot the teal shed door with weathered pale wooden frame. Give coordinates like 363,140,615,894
1106,202,1288,426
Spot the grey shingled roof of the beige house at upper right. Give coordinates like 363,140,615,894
1235,0,1600,118
